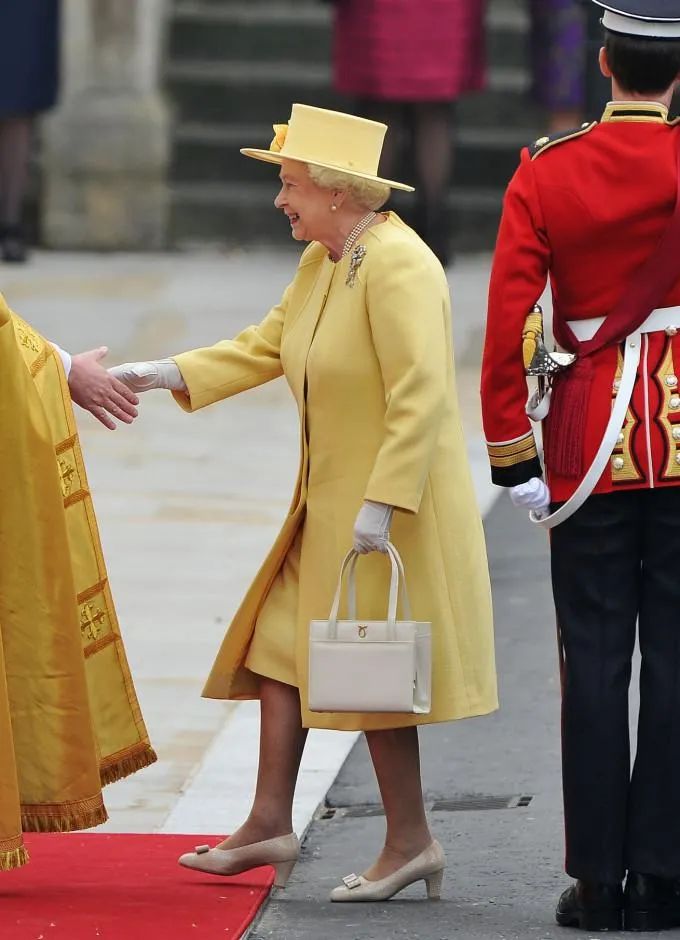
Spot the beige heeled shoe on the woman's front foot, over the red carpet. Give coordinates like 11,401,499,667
178,832,300,888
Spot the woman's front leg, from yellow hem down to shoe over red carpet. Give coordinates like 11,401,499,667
219,677,307,849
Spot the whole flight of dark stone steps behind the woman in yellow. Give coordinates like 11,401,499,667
165,0,542,251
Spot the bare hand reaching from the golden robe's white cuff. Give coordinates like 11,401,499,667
68,346,139,431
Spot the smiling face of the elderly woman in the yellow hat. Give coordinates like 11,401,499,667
274,160,333,242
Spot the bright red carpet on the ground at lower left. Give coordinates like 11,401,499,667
0,832,274,940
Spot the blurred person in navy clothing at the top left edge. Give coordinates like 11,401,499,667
0,0,59,262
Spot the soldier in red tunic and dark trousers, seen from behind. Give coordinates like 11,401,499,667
482,0,680,931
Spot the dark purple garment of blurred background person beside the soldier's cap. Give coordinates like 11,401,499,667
529,0,586,111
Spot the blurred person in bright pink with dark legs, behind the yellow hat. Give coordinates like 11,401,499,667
326,0,486,266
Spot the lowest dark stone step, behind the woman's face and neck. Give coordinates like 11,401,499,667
171,180,502,252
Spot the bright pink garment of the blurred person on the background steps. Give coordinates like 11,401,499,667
333,0,486,101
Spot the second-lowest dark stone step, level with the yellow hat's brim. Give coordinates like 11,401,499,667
172,123,536,188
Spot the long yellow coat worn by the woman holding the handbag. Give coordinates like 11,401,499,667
175,213,498,730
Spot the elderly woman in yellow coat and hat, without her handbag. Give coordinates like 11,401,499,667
114,104,497,901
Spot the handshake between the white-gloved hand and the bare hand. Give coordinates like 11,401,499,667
65,346,186,431
